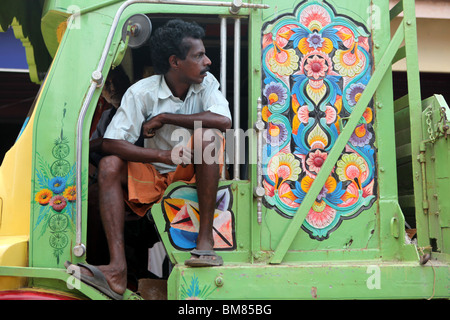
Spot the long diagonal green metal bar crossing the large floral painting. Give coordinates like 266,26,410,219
270,13,404,264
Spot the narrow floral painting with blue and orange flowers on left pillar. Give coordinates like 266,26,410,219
33,123,77,264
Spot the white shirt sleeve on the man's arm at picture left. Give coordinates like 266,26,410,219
104,89,151,144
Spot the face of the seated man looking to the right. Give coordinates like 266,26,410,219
178,38,211,84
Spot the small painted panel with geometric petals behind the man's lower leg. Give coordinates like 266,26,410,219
162,186,236,250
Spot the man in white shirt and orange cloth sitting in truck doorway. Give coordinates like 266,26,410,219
66,20,231,299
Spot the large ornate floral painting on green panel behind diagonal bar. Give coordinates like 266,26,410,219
262,1,376,240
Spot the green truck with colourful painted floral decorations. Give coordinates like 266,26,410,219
0,0,450,300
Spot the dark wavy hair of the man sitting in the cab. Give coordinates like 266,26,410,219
150,19,205,74
